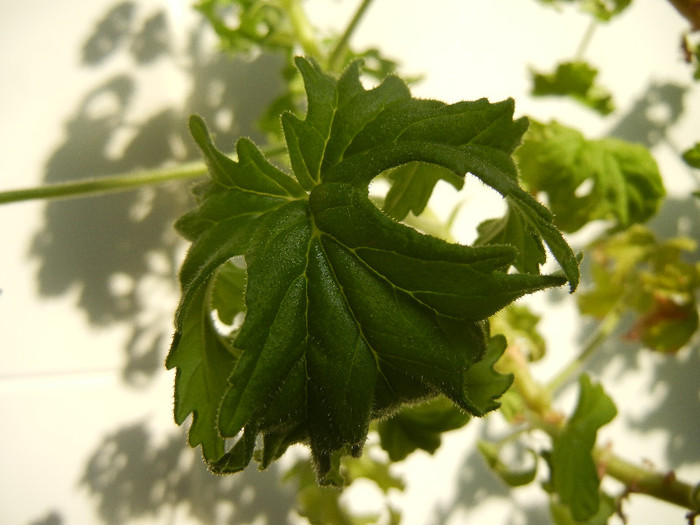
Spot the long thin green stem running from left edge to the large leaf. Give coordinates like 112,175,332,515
0,162,207,204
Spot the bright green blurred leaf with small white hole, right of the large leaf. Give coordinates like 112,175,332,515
516,122,665,232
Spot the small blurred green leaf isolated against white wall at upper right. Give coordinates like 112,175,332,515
530,61,615,115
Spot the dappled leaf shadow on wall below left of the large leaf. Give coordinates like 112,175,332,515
80,423,296,525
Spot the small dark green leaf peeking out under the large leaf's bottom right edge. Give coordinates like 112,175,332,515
377,397,470,461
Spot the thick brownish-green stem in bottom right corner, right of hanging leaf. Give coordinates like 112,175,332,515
593,448,700,512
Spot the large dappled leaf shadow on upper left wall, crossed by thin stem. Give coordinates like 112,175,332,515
30,2,284,384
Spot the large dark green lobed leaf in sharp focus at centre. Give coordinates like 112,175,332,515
167,58,578,482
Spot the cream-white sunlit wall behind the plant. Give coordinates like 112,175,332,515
0,0,700,525
